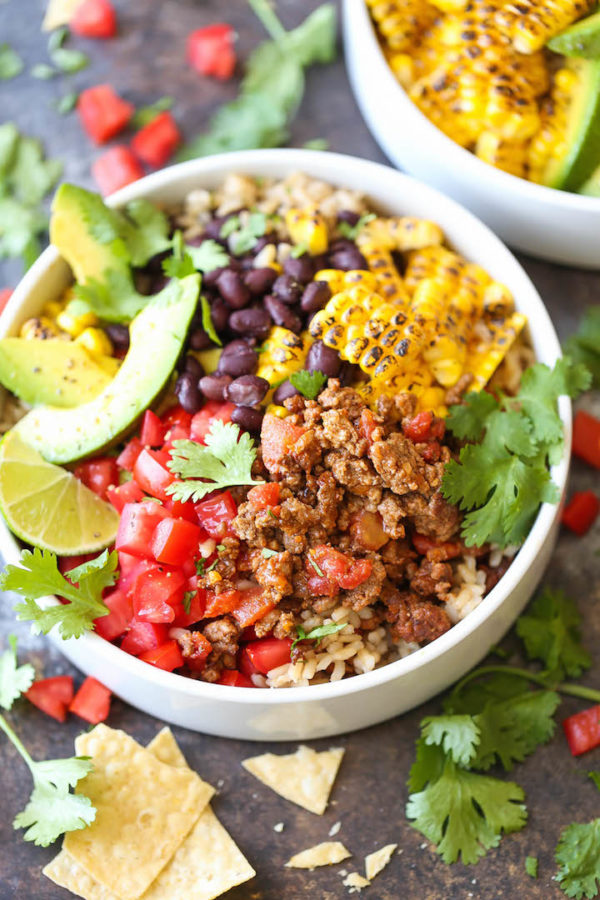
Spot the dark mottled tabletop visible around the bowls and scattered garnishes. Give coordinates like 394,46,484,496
0,0,600,900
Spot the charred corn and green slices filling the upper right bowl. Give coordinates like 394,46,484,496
366,0,600,196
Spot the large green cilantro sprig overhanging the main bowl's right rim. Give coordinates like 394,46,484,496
442,357,590,547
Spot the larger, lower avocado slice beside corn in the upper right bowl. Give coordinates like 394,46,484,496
541,59,600,191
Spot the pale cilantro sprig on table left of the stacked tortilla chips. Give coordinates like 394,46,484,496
0,636,96,847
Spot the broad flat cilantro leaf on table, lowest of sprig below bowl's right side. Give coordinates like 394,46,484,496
406,757,527,865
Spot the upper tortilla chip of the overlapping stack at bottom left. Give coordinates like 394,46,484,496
63,725,214,900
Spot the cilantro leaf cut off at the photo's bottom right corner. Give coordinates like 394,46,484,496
555,819,600,900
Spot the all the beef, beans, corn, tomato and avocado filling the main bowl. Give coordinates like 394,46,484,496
0,175,581,687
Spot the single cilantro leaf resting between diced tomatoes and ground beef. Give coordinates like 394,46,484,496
167,419,259,502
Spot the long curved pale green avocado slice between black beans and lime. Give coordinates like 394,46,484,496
15,275,200,463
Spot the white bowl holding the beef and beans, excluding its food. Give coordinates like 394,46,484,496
0,150,571,740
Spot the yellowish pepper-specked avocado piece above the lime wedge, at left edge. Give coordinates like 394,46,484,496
0,338,118,407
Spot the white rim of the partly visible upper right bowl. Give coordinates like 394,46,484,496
343,0,600,215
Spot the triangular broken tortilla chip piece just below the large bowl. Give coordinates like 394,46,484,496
242,746,344,816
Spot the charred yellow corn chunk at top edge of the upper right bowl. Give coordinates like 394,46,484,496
496,0,596,53
